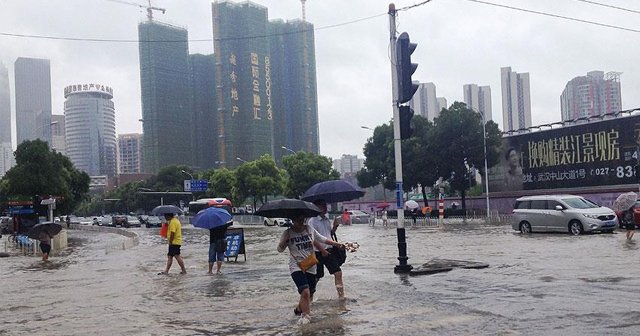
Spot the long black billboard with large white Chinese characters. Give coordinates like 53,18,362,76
488,115,640,192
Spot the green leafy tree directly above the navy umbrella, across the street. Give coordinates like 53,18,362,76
282,152,340,198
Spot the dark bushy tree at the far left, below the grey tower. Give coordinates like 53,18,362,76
0,139,89,213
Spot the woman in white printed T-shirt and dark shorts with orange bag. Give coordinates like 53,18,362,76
278,213,344,324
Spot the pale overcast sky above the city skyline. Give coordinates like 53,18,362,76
0,0,640,158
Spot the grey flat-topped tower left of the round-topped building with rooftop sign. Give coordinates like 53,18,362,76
15,57,51,145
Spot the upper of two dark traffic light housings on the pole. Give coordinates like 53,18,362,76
396,32,418,104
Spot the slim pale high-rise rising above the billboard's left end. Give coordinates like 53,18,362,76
500,67,531,132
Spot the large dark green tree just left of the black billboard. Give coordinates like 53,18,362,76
431,102,502,208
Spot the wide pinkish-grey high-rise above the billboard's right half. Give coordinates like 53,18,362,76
560,71,622,121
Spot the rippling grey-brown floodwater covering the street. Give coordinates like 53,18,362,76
0,224,640,336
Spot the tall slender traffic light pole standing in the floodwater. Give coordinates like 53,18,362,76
389,3,413,273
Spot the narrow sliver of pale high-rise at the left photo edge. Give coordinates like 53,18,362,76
0,62,15,177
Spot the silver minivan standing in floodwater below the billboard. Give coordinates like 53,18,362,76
511,195,618,235
